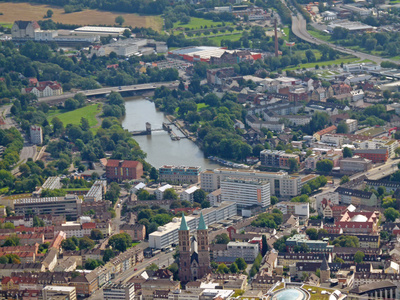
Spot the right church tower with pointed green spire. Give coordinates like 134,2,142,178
197,213,211,278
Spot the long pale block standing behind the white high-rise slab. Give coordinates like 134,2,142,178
200,168,306,197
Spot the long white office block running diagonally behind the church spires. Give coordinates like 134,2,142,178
149,201,237,249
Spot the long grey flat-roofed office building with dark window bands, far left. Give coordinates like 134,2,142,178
14,195,82,219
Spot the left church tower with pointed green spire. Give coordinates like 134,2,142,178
179,213,192,282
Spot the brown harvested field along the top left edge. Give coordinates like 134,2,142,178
0,3,163,30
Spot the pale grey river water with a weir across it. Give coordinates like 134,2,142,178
122,97,219,170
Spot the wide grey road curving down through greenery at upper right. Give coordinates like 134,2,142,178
292,13,399,65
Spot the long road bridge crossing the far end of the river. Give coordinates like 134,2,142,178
38,81,179,102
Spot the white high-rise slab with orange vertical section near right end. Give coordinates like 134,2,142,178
221,178,271,208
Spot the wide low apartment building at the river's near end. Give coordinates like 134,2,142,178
158,165,201,184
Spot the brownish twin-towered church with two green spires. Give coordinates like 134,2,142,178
179,213,211,282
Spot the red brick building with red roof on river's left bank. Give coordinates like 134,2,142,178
106,159,143,181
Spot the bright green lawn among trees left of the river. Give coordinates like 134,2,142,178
47,103,102,127
